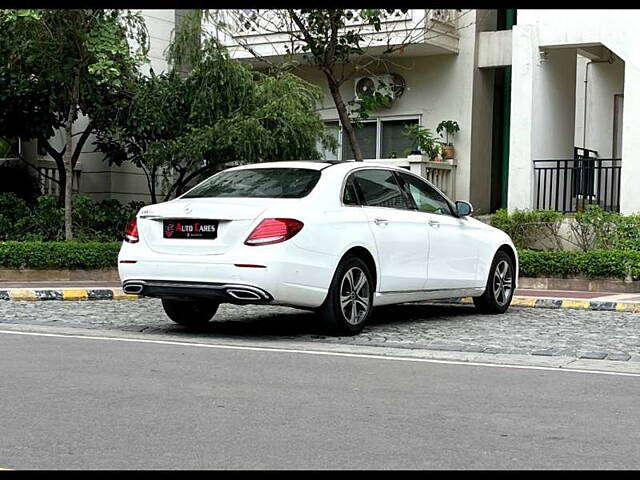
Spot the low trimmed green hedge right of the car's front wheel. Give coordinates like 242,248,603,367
518,250,640,280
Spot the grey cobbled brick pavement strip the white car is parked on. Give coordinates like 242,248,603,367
0,298,640,362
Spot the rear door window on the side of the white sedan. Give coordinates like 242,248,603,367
353,169,413,210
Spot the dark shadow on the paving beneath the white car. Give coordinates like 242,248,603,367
172,304,477,338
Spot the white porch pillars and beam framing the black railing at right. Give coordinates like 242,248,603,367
508,10,640,213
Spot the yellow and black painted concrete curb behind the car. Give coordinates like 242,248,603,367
0,288,640,313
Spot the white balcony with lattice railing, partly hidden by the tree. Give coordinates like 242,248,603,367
216,9,469,59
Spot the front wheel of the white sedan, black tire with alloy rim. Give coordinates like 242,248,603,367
473,251,515,314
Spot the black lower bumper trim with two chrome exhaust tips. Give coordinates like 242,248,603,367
122,279,273,305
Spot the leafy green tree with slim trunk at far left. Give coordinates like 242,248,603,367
0,9,148,240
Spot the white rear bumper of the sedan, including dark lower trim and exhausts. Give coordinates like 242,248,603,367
118,242,337,308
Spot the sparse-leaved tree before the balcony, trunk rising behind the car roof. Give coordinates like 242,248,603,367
171,9,465,161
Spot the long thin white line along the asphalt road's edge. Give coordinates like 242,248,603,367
0,330,640,377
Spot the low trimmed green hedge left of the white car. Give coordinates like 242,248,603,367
0,241,121,269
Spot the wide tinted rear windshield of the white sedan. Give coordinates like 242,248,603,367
182,168,320,198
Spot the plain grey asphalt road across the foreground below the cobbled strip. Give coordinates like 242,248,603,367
0,332,640,469
